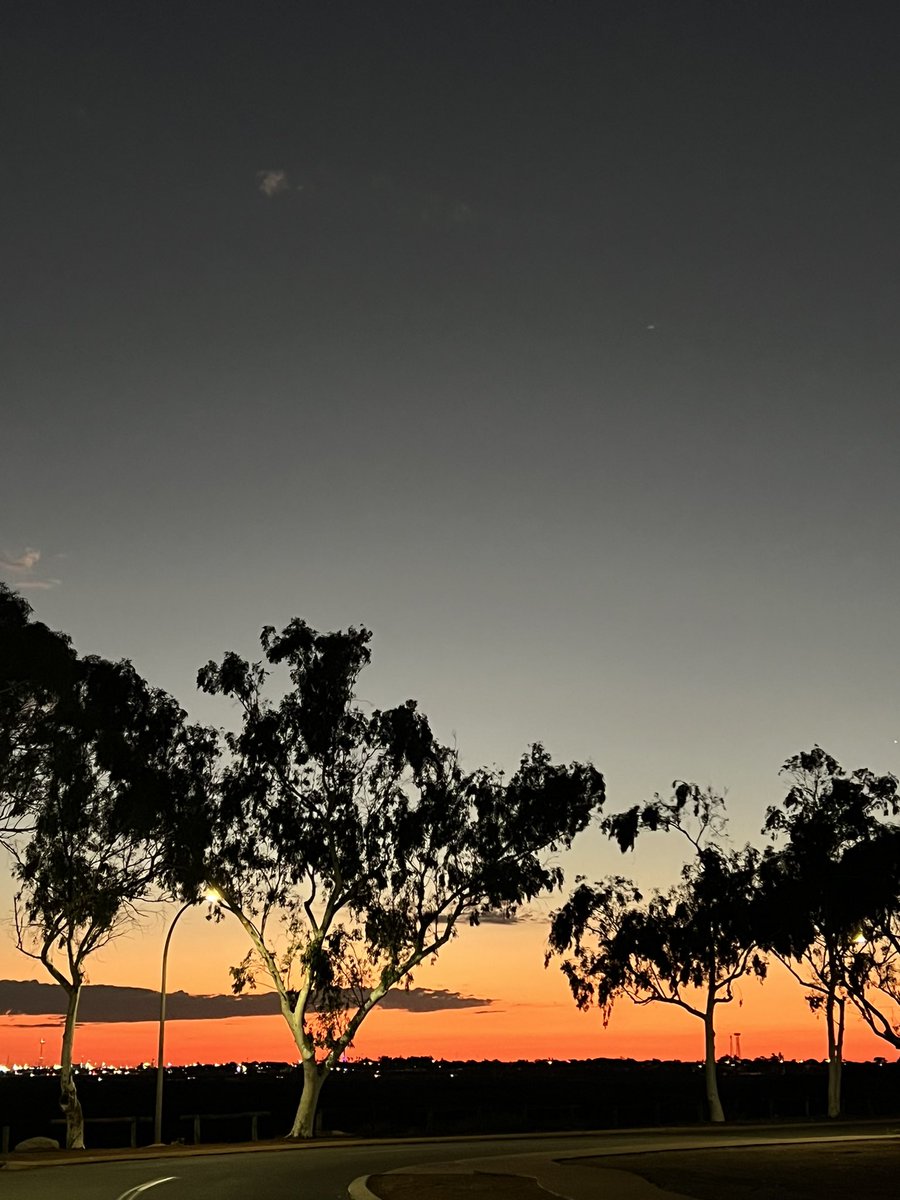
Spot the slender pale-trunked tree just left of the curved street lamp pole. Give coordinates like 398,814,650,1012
12,643,210,1148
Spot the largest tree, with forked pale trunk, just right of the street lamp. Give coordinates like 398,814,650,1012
197,619,604,1138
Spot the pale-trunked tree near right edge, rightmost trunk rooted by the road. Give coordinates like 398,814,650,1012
760,746,900,1117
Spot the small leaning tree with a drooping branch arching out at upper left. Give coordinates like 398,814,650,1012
545,782,766,1122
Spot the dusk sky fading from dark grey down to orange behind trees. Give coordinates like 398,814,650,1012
0,0,900,1061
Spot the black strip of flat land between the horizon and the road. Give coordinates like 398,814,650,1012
0,1060,900,1152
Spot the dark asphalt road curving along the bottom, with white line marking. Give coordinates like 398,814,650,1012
0,1124,896,1200
